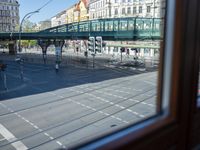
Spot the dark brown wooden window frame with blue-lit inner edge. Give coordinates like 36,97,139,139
73,0,200,150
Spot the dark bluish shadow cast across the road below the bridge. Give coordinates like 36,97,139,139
0,52,158,100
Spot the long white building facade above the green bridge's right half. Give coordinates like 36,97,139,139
89,0,165,20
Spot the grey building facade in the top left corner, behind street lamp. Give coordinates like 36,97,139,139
0,0,19,32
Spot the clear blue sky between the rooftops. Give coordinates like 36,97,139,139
18,0,78,23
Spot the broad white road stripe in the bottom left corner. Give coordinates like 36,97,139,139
0,124,28,150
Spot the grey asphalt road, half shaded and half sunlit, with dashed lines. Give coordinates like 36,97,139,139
0,62,157,150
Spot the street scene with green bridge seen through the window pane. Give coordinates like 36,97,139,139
0,0,165,150
